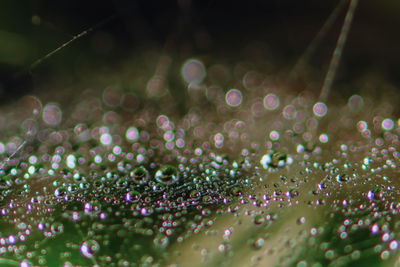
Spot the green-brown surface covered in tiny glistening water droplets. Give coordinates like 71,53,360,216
0,12,400,266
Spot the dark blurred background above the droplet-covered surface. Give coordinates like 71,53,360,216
0,0,400,100
